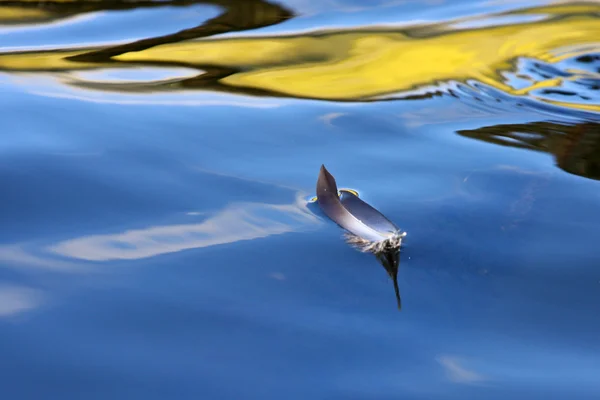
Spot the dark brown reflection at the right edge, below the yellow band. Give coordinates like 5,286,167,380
457,122,600,180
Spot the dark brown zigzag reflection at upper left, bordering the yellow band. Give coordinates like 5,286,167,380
0,0,293,94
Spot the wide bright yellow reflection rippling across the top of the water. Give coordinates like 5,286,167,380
0,3,600,112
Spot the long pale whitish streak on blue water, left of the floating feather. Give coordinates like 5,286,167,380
48,196,320,261
